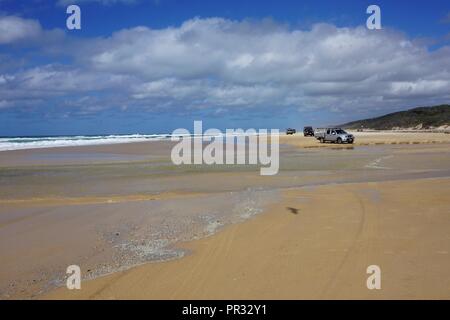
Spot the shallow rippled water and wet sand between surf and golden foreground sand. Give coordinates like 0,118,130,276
0,145,450,298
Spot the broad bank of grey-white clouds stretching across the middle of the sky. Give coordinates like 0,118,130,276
0,18,450,117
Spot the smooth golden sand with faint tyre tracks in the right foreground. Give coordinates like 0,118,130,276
43,179,450,299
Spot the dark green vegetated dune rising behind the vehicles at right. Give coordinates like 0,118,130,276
341,104,450,130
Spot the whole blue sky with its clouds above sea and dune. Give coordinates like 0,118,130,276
0,0,450,136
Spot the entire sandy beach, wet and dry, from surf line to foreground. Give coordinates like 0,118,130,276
0,132,450,299
